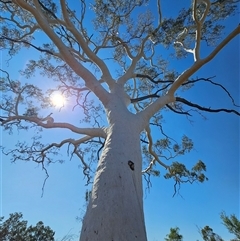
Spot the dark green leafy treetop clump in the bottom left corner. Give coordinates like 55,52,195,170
0,213,55,241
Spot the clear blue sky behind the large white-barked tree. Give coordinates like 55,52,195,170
0,1,240,241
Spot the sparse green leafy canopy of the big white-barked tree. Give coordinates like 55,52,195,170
0,0,240,193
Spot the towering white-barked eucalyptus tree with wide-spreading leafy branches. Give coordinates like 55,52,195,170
0,0,240,241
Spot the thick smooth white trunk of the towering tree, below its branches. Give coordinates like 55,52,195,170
80,101,147,241
